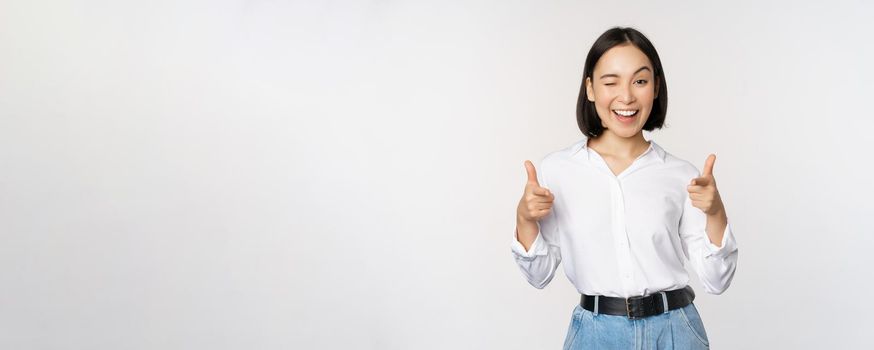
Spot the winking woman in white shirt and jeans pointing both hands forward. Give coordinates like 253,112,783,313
512,27,737,349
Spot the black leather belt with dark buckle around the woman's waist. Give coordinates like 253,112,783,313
580,286,695,319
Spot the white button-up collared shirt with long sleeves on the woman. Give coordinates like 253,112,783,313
511,138,737,298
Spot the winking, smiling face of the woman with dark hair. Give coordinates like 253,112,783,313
586,44,658,137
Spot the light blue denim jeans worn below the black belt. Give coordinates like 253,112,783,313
564,304,710,350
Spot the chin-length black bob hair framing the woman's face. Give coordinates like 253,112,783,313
577,27,668,138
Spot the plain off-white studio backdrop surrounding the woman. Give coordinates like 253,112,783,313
0,0,874,349
